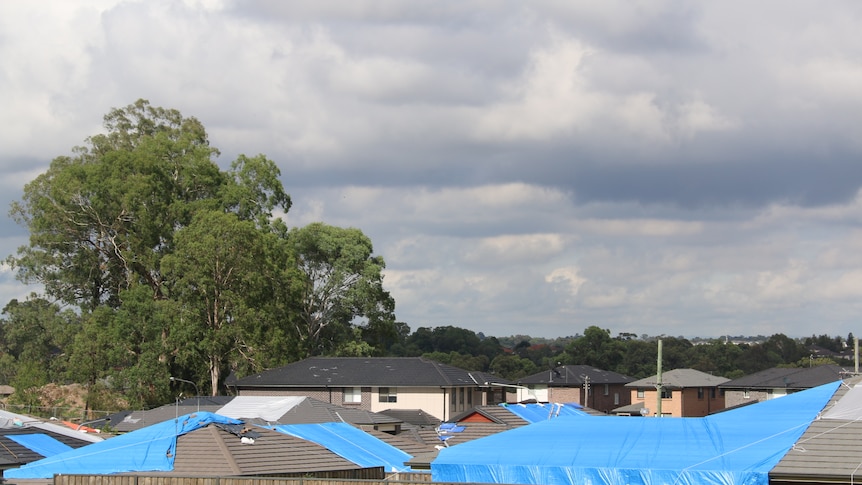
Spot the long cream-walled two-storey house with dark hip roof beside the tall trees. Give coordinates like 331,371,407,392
232,357,507,421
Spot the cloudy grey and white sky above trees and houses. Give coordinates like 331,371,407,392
0,0,862,338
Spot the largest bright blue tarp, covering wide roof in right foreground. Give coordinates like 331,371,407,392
431,382,839,485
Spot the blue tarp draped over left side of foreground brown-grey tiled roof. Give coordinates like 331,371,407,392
3,412,241,478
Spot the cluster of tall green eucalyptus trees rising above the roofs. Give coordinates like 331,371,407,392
0,100,395,404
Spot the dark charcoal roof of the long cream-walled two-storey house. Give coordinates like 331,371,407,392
234,357,508,389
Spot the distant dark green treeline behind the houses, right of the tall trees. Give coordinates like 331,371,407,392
389,326,854,380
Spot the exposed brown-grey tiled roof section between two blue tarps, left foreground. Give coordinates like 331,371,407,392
171,425,368,476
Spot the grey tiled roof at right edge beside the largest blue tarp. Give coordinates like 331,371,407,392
769,377,862,483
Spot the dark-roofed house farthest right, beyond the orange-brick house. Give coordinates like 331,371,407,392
718,365,846,408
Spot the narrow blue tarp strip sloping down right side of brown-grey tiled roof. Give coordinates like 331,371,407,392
272,423,413,472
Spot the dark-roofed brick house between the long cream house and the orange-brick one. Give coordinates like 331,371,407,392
517,365,634,413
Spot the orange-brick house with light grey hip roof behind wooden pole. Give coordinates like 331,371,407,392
613,369,730,417
